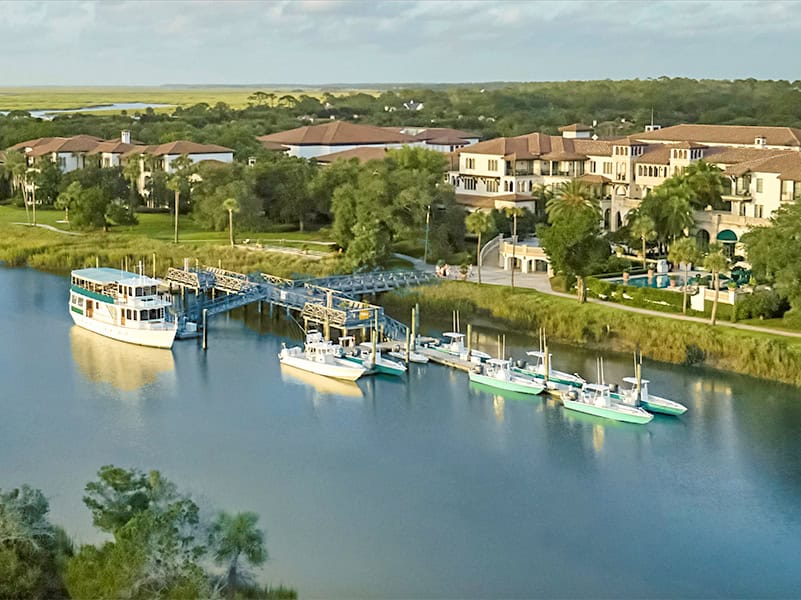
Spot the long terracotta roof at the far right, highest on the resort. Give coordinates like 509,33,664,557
632,123,801,148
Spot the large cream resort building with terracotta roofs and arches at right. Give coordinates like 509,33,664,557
447,124,801,254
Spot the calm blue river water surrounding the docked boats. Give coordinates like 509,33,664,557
0,269,801,598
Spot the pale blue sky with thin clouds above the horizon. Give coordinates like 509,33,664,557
0,0,801,86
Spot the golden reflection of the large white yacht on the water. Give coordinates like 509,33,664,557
70,326,175,392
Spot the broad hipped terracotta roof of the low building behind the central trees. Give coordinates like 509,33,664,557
258,121,415,146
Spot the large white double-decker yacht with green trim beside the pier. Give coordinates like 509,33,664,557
69,267,178,348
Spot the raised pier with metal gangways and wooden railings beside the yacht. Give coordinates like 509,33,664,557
164,264,435,346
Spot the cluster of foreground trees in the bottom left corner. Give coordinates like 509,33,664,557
0,465,297,600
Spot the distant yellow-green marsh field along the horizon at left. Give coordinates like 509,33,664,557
0,87,373,114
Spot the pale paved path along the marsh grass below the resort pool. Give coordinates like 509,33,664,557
474,265,801,338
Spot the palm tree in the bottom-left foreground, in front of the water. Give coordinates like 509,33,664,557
210,512,267,598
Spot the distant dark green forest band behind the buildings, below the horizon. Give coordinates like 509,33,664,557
0,77,801,160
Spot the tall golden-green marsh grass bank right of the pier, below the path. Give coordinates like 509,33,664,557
383,282,801,386
